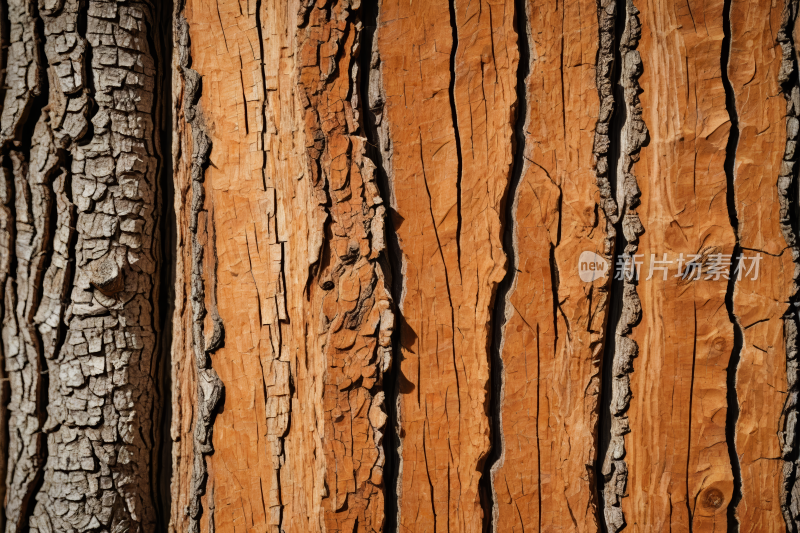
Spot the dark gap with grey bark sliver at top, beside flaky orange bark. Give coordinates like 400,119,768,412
360,0,405,533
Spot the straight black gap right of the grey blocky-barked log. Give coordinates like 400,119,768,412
152,0,178,533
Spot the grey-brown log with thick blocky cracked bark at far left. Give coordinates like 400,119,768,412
0,0,162,532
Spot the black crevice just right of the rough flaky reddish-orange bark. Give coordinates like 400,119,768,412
359,0,404,533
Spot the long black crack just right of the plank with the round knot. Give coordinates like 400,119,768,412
720,0,744,533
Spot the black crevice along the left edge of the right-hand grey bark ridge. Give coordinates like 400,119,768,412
595,0,627,533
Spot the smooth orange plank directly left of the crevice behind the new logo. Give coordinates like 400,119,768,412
493,1,616,531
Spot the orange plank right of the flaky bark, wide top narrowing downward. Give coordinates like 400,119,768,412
375,0,518,531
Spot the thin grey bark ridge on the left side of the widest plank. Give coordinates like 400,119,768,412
175,2,224,533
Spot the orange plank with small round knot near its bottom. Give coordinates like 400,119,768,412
622,0,735,531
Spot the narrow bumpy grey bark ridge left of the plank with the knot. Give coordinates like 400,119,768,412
596,0,647,533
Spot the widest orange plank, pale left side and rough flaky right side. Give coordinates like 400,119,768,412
172,0,393,532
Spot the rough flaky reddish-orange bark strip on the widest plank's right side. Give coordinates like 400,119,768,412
297,0,394,532
